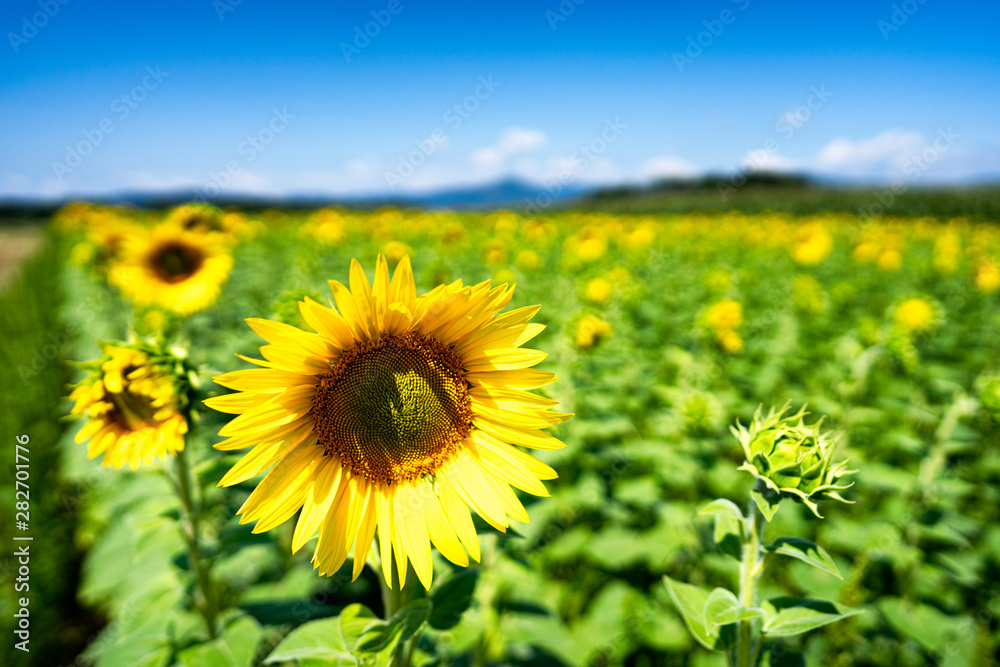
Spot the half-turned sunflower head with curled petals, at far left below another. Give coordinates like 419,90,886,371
70,345,188,470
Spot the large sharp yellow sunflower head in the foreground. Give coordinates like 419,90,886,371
206,255,570,587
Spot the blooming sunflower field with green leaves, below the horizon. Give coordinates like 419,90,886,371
0,203,1000,667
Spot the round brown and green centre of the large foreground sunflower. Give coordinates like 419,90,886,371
312,332,472,484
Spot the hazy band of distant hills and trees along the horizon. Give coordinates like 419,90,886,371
0,173,1000,224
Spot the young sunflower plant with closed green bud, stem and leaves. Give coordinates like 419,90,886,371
664,405,862,667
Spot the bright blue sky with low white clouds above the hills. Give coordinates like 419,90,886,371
0,0,1000,197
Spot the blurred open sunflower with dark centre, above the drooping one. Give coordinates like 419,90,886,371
110,224,233,315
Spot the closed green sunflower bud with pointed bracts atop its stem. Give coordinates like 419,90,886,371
731,405,855,521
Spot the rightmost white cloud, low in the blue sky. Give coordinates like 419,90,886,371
811,129,925,173
